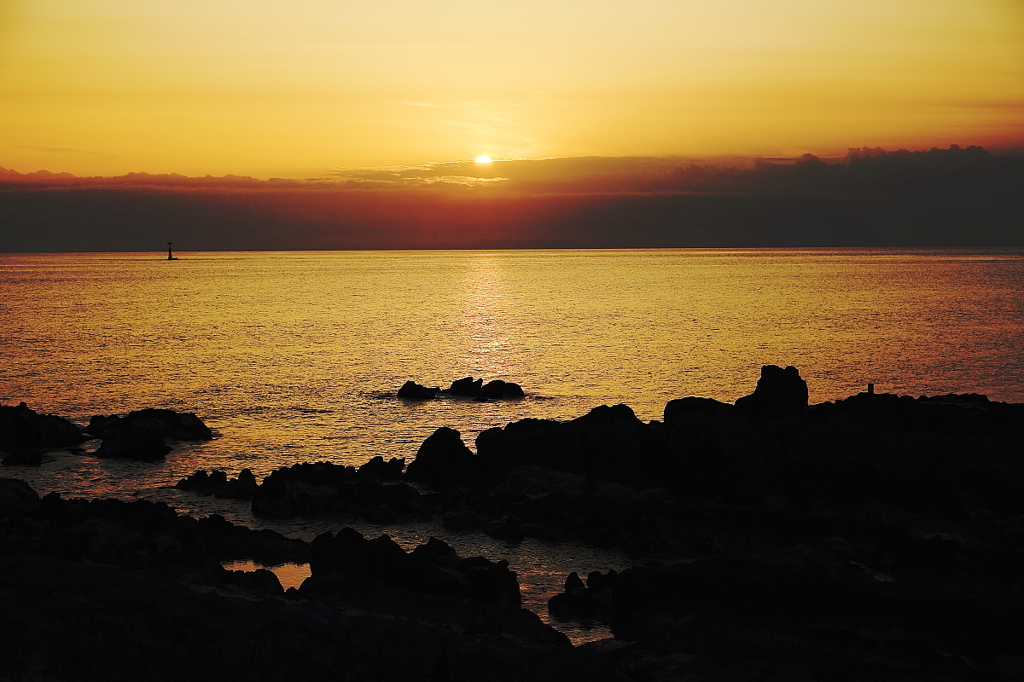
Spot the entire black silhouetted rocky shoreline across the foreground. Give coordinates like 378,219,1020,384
0,366,1024,681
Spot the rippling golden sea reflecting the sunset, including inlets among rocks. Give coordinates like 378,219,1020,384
0,248,1024,641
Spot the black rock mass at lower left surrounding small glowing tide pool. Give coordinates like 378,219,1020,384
0,479,614,682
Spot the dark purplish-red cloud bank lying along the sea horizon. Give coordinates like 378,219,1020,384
0,146,1024,252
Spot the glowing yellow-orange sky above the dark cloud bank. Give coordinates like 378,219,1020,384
0,0,1024,177
